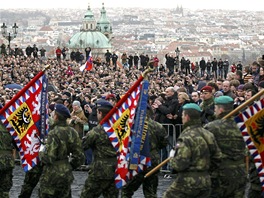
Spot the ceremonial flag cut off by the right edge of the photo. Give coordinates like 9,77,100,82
235,99,264,191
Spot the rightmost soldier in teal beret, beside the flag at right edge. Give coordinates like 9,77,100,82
204,96,247,198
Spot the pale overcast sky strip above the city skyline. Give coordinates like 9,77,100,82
0,0,264,10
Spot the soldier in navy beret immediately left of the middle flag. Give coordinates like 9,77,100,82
81,99,118,198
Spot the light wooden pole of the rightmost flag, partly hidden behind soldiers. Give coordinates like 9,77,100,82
144,89,264,178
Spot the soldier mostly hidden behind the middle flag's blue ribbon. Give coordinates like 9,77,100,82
122,106,168,198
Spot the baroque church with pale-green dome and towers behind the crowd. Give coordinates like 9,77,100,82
68,3,112,56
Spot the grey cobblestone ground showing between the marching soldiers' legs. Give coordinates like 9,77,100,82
10,165,173,198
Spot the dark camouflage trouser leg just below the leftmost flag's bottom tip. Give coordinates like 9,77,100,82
18,163,42,198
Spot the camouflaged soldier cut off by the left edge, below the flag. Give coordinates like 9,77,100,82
0,123,15,198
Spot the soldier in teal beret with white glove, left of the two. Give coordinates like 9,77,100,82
164,103,221,198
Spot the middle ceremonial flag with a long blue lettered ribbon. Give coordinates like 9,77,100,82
100,76,151,188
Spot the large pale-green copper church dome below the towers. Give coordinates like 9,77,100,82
68,31,111,49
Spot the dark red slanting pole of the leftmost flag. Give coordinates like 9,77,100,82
0,65,50,114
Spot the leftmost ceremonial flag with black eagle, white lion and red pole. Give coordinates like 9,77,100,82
0,71,48,171
